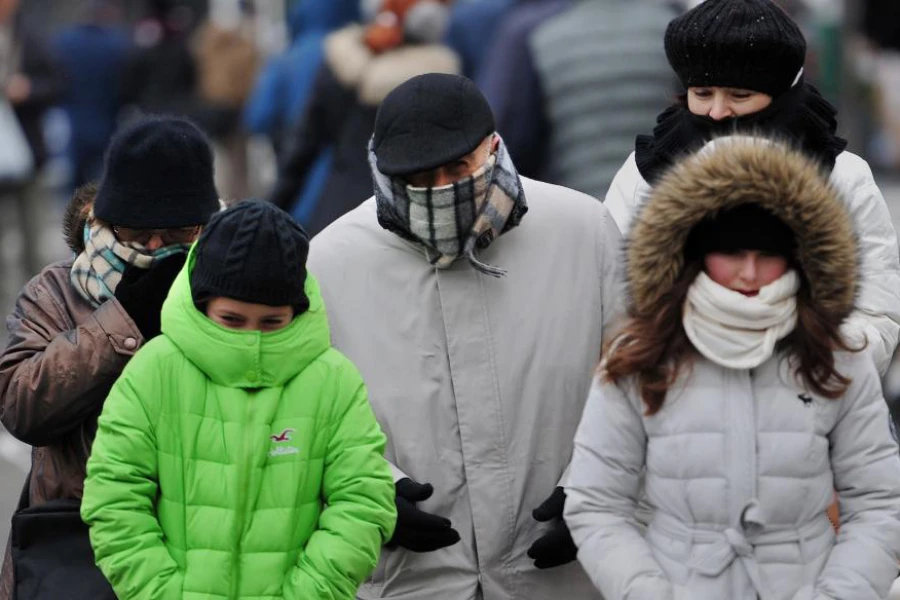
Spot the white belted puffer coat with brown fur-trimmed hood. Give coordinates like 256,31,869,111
565,141,900,600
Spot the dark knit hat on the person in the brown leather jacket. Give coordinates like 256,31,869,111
94,117,219,229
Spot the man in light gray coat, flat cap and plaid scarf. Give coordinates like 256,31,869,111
309,74,623,600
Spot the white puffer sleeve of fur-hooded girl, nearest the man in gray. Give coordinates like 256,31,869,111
564,381,674,600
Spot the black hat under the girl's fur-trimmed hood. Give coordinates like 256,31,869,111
684,204,797,262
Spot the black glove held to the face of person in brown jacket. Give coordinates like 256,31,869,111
115,252,187,340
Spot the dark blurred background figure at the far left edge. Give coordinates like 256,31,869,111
0,0,63,275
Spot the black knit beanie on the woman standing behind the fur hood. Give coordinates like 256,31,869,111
666,0,806,97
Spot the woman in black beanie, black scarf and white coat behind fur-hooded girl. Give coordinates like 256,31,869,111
605,0,900,375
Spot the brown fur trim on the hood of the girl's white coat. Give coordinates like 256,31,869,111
626,136,858,323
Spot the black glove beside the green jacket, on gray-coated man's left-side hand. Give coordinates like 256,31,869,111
386,477,459,552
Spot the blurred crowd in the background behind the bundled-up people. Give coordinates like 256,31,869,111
0,0,900,312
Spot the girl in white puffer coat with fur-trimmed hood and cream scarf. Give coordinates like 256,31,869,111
565,137,900,600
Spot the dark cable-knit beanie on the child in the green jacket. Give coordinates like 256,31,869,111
191,200,309,317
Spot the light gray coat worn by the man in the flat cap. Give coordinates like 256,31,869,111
309,179,622,600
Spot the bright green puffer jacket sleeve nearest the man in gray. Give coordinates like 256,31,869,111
284,377,397,600
